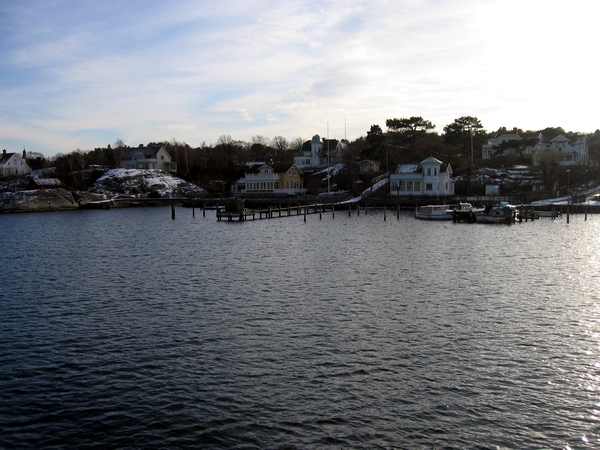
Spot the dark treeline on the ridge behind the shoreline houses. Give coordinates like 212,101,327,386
28,116,600,191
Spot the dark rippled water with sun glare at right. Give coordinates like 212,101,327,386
0,208,600,449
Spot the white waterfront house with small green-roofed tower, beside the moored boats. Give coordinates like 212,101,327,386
390,156,454,197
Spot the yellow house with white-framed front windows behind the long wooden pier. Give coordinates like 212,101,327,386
231,164,306,196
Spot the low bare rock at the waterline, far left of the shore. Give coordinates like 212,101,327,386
0,189,79,212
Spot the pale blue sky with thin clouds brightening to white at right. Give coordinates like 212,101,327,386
0,0,600,156
